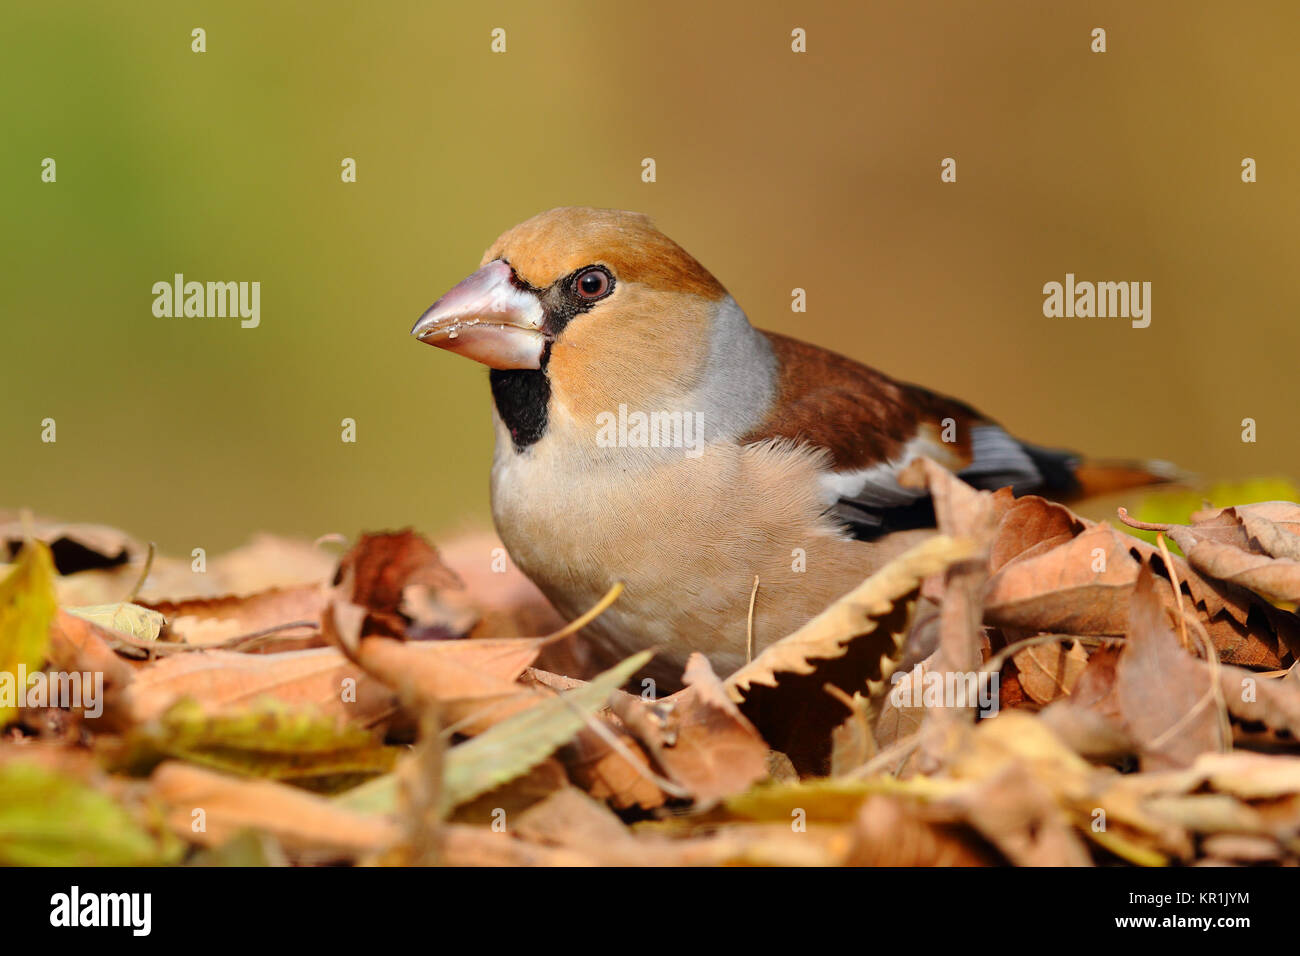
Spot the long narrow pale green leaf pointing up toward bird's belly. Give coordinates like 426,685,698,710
338,650,651,813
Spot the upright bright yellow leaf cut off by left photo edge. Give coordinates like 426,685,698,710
0,541,57,727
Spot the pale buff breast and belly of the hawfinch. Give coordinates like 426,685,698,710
491,414,894,674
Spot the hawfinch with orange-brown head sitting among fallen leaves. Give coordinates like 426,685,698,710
411,208,1161,674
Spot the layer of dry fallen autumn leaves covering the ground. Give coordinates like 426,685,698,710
0,478,1300,866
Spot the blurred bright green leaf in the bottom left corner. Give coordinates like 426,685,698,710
0,760,181,866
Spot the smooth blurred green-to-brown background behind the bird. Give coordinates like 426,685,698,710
0,0,1300,553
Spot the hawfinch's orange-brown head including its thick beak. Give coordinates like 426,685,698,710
411,207,735,424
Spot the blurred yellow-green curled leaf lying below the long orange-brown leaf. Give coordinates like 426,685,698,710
113,697,399,790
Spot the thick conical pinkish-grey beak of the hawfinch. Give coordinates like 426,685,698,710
411,259,546,368
